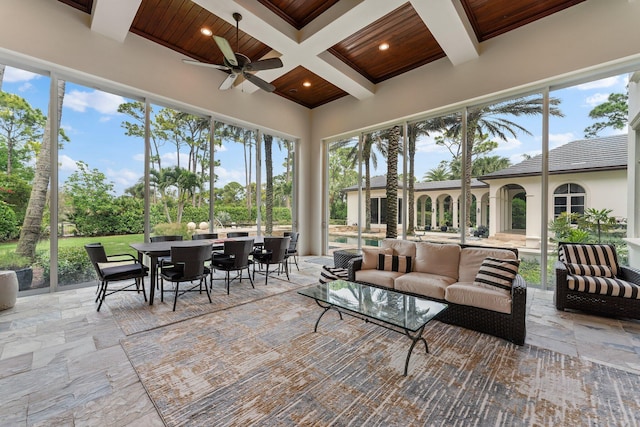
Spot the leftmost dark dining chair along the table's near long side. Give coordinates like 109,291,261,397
160,245,212,311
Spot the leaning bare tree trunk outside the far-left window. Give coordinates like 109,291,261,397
16,80,66,258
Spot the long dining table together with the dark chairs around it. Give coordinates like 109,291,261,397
85,232,299,311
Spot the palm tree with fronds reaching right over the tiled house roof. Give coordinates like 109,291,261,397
448,97,564,226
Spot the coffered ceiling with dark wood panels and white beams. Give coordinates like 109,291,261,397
59,0,585,108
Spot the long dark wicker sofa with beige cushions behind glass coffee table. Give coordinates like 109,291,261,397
348,239,527,345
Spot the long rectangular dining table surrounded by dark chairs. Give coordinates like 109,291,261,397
129,236,264,305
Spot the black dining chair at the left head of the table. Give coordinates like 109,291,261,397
84,243,149,311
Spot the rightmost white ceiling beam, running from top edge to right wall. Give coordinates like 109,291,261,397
411,0,480,65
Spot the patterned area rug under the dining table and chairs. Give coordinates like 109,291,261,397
110,261,320,335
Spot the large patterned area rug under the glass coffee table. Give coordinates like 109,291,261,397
122,291,640,426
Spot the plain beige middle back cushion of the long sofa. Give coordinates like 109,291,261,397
413,242,460,282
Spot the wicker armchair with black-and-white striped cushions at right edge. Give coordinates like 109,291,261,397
555,243,640,319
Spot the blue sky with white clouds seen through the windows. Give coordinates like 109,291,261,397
2,67,628,194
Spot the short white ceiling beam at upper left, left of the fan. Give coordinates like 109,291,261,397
91,0,142,43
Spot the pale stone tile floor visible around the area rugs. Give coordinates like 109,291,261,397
0,257,640,426
